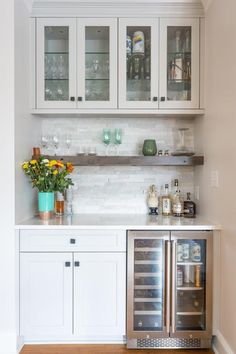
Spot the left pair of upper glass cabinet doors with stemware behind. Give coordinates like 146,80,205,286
37,18,117,108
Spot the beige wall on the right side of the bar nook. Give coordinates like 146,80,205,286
196,0,236,354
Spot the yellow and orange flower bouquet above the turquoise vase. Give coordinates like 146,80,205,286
22,157,74,193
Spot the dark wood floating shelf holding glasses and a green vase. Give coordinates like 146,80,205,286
41,155,204,166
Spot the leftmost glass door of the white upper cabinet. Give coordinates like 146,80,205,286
37,19,76,108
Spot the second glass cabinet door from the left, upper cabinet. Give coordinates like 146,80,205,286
77,18,117,108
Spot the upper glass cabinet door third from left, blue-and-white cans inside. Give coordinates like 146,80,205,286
119,19,158,108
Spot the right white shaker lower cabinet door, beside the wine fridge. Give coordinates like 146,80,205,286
74,253,126,341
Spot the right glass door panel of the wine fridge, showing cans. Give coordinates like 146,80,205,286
172,235,211,335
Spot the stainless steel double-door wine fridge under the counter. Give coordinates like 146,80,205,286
127,231,212,348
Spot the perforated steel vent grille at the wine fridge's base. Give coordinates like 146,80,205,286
137,338,201,348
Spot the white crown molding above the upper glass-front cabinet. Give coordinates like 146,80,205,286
31,0,204,17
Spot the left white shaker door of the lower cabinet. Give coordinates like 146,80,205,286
20,253,72,340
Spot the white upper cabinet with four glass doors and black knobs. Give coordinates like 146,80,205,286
32,17,203,114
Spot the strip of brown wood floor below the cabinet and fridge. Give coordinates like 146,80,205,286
20,344,214,354
